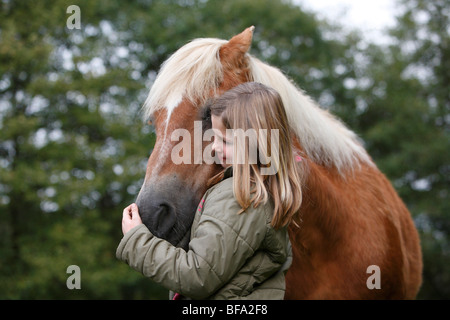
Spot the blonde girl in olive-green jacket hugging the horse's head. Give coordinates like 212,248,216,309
116,82,301,299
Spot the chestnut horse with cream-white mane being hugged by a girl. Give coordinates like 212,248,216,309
136,26,423,299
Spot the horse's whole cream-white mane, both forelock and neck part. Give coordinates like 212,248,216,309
143,38,373,172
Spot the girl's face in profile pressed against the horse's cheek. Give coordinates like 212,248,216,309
211,115,233,168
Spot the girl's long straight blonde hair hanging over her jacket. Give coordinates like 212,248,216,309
208,82,302,228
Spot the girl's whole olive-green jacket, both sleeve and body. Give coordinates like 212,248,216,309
116,167,292,299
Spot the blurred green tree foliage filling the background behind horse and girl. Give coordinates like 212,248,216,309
0,0,450,299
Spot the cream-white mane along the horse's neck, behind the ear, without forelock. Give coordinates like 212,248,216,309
249,55,372,171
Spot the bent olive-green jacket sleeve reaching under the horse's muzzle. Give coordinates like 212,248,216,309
116,188,266,299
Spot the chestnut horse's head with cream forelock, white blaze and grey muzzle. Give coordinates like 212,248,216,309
136,27,254,248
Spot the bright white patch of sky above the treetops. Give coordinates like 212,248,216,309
294,0,397,43
